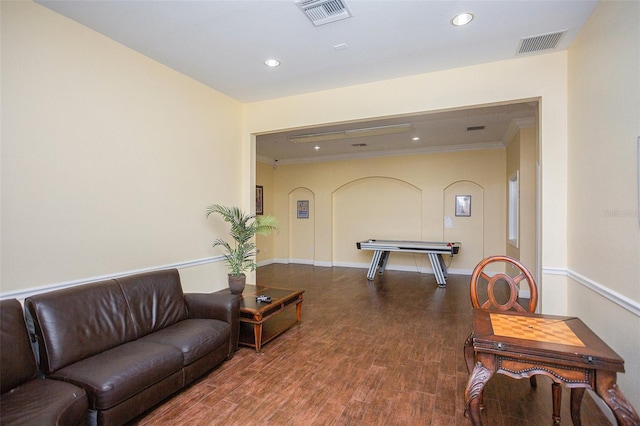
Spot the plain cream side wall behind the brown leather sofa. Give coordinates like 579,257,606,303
1,2,243,294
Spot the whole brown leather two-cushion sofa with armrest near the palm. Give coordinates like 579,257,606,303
25,270,240,425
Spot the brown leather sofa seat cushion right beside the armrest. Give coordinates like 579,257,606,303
139,319,231,365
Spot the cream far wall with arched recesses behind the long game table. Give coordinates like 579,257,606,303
258,149,505,274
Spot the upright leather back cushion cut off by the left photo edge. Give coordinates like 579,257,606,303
0,299,38,393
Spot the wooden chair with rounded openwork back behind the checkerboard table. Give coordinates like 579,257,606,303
464,256,562,424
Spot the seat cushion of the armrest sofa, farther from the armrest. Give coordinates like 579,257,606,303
49,341,183,410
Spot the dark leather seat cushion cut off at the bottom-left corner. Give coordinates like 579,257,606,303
0,379,88,425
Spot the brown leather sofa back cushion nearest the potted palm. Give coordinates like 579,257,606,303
116,269,188,338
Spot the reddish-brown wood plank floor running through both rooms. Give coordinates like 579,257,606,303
136,264,609,426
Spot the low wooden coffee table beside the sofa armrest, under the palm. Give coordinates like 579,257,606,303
239,285,304,352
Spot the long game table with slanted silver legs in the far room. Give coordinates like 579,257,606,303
356,240,461,287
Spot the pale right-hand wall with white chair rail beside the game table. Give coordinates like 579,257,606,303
567,1,640,410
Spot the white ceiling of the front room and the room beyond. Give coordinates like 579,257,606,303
38,0,597,161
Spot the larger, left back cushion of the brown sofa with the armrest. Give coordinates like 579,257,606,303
25,280,135,374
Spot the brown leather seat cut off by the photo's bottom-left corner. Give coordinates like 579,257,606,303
0,299,88,425
